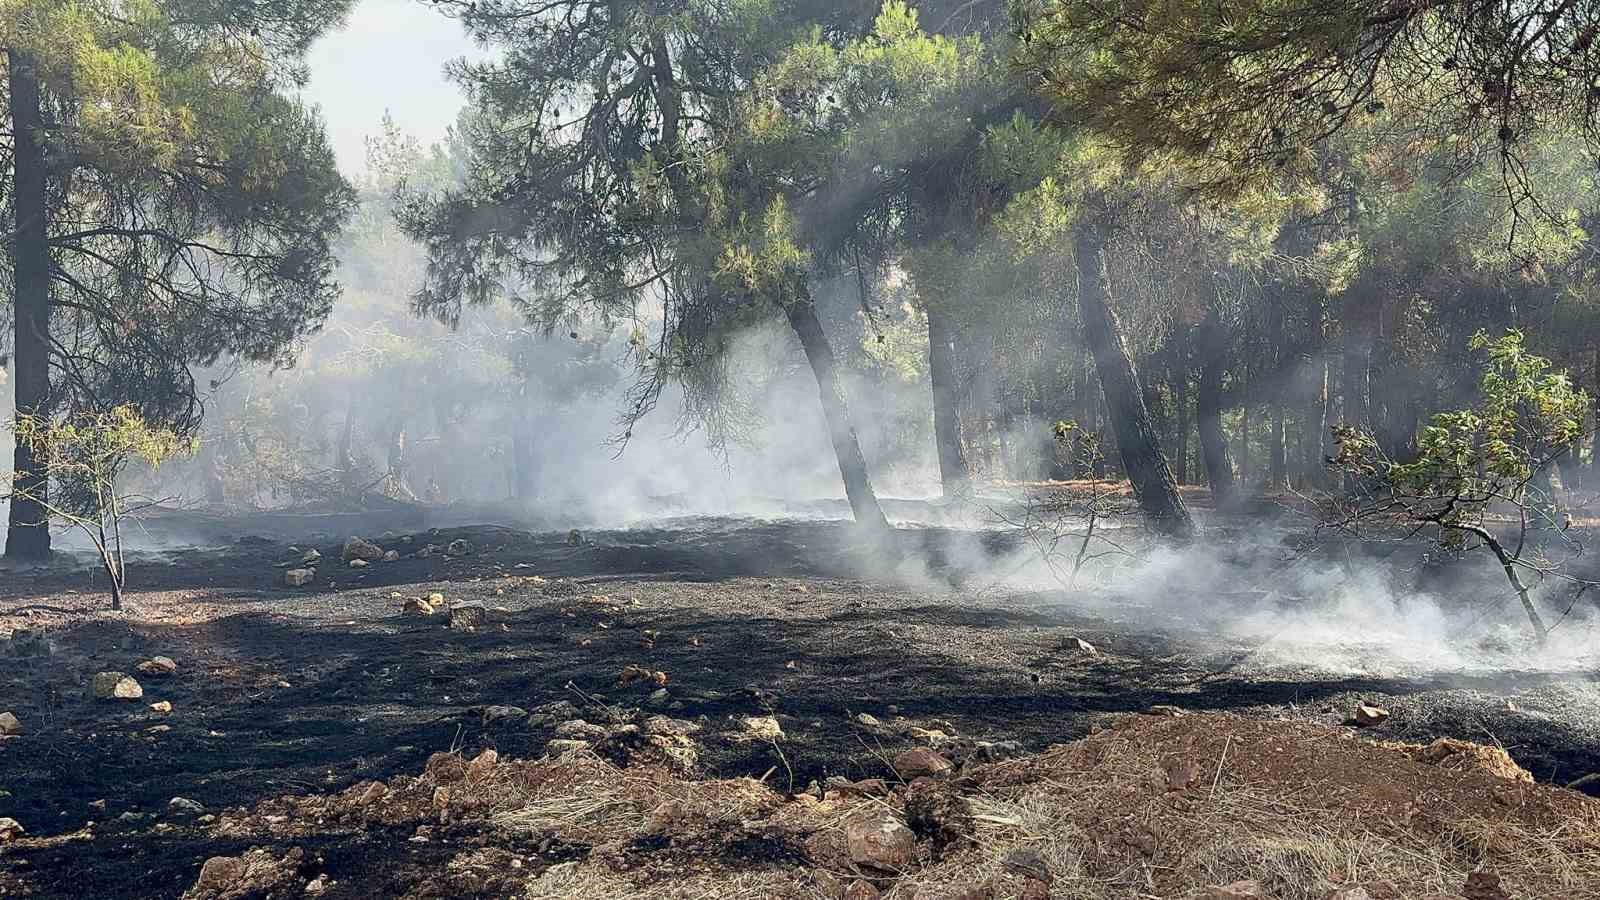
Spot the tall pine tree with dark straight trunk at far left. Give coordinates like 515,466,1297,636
0,0,349,559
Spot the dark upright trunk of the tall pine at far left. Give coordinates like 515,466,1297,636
5,50,50,560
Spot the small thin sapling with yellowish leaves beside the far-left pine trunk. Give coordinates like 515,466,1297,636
11,405,195,610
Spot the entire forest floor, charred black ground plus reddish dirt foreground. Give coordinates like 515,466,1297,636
0,499,1600,900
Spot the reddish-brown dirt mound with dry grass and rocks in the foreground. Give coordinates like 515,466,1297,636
175,714,1600,900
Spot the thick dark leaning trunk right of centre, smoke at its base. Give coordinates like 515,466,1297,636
1074,226,1194,536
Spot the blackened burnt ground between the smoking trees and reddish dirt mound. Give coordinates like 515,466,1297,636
0,509,1600,898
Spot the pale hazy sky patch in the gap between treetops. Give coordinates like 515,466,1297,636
304,0,480,175
